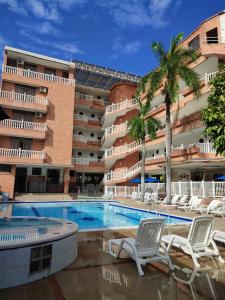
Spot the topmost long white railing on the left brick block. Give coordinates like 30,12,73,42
2,65,75,85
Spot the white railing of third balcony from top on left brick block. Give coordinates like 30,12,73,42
0,119,48,131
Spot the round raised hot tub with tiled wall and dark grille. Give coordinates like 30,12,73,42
0,217,78,289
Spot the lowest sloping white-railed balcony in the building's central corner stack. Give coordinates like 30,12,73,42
104,161,142,184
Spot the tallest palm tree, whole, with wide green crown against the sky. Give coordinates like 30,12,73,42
139,33,201,204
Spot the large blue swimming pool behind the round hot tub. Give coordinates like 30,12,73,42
9,201,191,231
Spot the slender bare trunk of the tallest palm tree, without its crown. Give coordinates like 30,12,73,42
165,95,172,204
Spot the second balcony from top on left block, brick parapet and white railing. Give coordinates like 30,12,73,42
0,90,49,113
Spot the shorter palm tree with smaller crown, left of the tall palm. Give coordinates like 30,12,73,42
128,98,160,201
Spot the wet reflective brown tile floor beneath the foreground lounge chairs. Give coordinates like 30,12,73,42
0,228,225,300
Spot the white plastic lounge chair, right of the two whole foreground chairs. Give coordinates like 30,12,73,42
162,216,224,268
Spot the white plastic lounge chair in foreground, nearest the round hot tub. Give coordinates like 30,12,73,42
108,218,173,276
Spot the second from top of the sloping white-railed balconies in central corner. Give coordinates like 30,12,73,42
102,121,128,148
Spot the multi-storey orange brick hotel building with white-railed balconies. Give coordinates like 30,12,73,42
0,12,225,198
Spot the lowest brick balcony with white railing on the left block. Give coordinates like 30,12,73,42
0,148,46,164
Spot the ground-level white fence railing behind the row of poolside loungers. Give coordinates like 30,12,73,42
105,181,225,198
